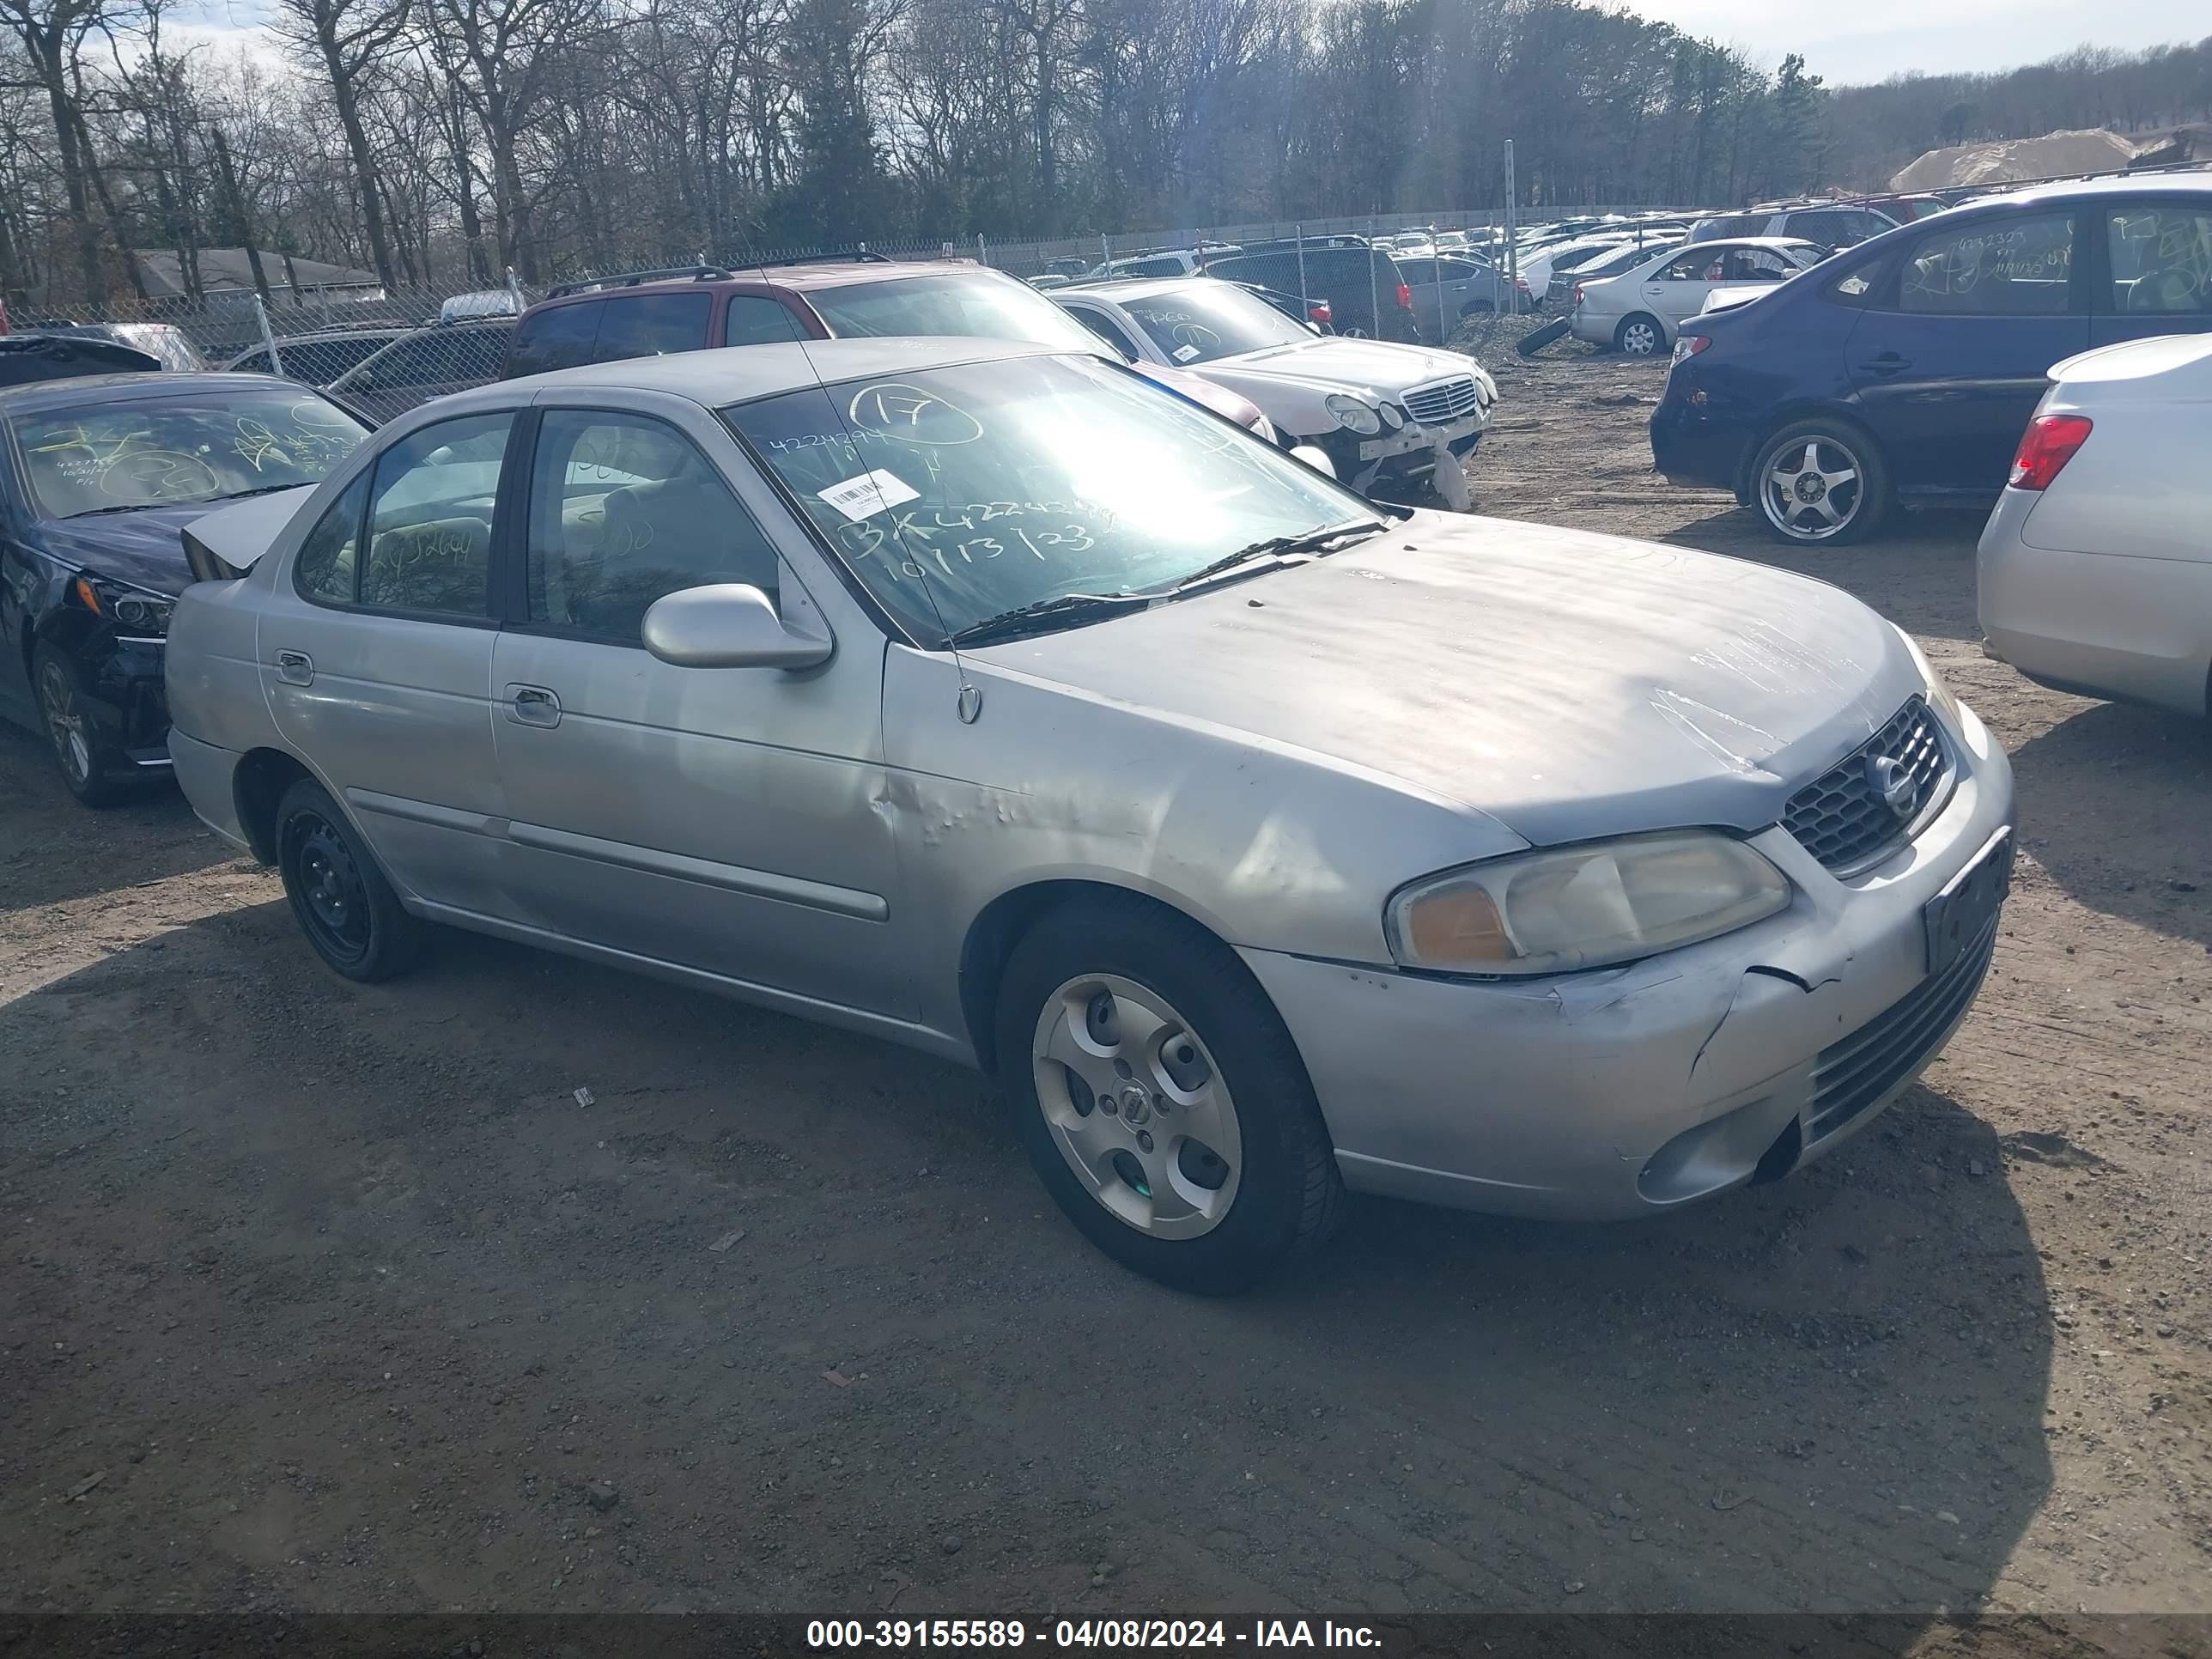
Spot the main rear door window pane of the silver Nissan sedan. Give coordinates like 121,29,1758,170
361,411,515,617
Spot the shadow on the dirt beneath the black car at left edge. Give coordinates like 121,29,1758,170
0,726,239,914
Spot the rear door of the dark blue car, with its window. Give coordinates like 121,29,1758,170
1844,208,2088,498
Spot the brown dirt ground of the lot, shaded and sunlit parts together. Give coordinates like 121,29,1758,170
0,345,2212,1652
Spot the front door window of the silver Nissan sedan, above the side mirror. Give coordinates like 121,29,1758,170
529,410,776,646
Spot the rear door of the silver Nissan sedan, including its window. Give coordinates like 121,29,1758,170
258,410,515,914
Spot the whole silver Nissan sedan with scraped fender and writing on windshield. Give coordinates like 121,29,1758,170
168,338,2013,1290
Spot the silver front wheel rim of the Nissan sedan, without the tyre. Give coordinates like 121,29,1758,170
1030,973,1243,1239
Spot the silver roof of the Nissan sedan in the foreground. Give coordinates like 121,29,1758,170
495,334,1068,410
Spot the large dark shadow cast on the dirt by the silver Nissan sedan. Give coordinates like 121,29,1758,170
0,902,2053,1617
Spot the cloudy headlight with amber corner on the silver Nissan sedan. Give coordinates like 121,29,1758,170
1382,830,1790,973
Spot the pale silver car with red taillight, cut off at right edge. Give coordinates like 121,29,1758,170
1978,334,2212,714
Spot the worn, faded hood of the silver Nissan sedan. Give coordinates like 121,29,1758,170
963,514,1923,845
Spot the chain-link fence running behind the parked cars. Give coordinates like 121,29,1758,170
11,208,1690,420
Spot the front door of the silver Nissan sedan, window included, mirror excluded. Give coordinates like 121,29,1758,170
493,394,911,1013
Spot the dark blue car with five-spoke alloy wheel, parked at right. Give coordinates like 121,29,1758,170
1652,173,2212,544
